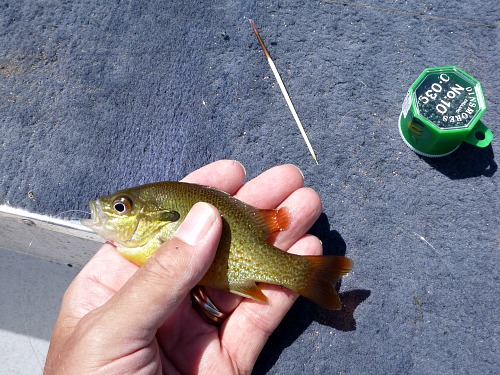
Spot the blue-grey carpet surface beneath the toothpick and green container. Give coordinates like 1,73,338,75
0,0,500,374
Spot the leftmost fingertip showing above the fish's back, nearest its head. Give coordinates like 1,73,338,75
181,160,246,194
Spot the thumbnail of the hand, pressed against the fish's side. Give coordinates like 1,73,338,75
175,202,217,246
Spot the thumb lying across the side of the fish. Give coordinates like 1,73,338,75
103,203,222,335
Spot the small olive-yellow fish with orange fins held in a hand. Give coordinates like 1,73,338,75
82,181,352,310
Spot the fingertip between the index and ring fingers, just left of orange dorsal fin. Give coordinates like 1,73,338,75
235,164,304,208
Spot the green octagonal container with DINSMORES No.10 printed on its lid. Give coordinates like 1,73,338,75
399,66,493,157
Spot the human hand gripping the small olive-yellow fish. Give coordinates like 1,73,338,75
45,161,322,374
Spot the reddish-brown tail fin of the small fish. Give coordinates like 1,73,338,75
297,255,353,310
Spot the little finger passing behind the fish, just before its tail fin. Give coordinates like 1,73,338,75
221,235,322,372
